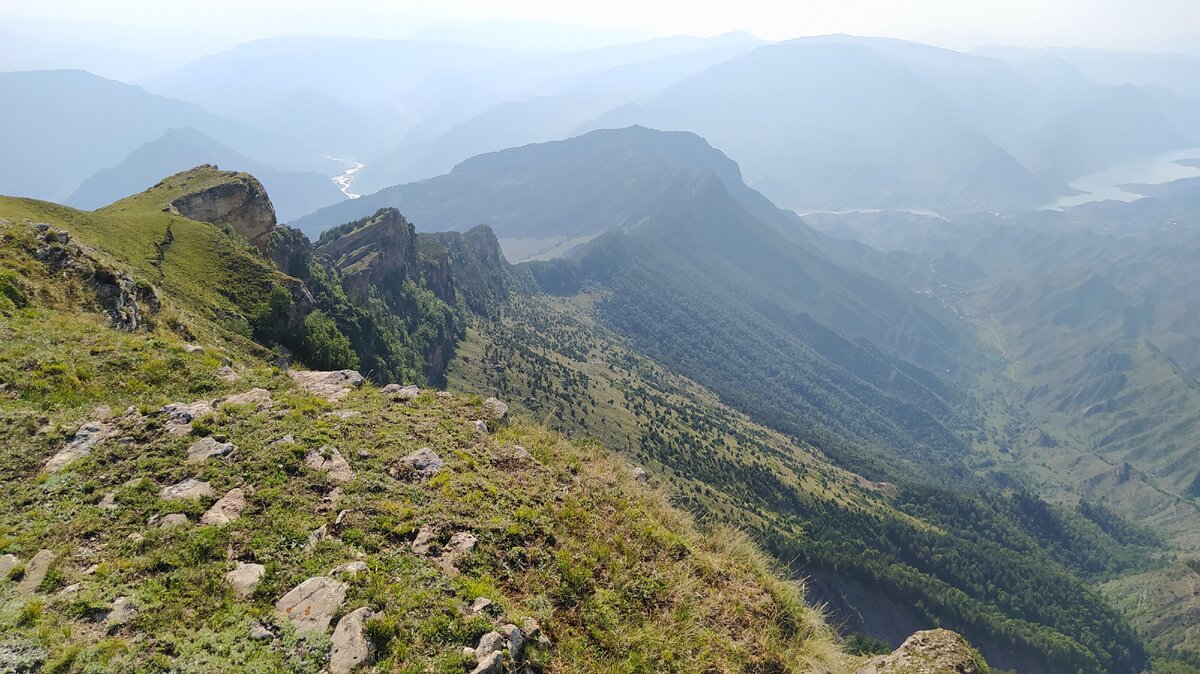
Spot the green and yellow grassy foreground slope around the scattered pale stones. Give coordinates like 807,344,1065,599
0,191,840,673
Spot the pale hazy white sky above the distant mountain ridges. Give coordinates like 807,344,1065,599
0,0,1200,53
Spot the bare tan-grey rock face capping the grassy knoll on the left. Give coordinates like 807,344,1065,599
170,166,276,253
